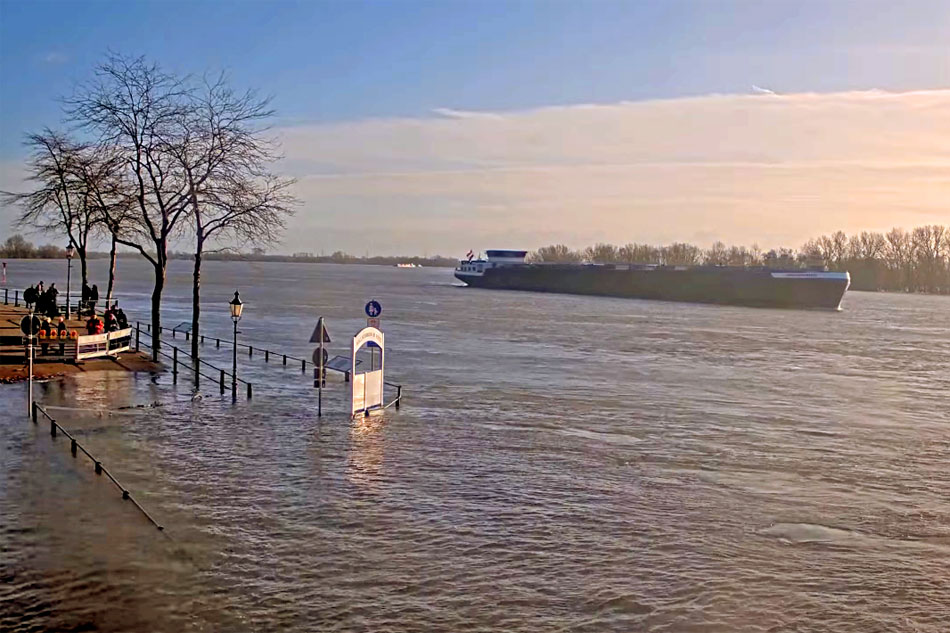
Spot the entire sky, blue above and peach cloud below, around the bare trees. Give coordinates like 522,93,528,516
0,0,950,254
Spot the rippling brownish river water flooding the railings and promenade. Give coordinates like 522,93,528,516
0,261,950,632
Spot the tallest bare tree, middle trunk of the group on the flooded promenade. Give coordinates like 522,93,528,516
67,55,190,360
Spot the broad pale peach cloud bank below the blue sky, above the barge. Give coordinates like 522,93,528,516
281,90,950,252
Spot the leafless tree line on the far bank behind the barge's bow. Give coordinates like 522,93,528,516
528,225,950,294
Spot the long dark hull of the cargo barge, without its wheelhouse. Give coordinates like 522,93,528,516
455,264,850,310
